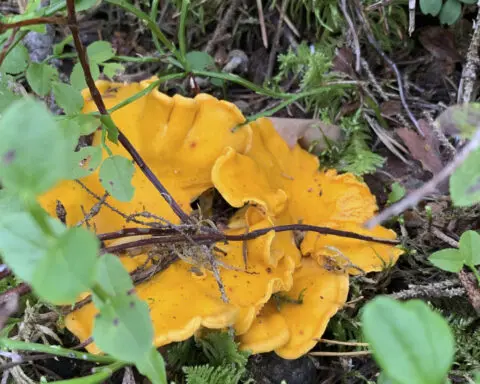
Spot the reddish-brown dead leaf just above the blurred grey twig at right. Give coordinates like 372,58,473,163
395,120,443,174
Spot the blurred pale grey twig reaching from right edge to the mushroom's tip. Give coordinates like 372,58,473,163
365,129,480,229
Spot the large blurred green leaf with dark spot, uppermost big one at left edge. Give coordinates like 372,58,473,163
0,98,68,195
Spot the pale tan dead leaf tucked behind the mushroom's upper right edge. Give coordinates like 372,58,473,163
270,117,342,154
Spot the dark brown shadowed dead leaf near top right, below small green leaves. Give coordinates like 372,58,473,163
418,26,462,62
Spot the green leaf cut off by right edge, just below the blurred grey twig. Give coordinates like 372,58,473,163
450,149,480,207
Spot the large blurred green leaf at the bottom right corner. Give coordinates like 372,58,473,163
362,296,455,384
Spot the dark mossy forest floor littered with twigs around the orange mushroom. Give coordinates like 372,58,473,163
0,0,480,384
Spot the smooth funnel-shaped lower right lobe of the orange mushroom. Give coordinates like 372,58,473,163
239,258,348,359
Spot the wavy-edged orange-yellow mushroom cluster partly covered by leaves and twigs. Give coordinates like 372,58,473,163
40,78,402,359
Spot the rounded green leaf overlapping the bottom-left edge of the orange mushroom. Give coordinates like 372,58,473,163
93,294,153,362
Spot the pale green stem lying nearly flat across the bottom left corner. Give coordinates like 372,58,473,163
0,338,117,364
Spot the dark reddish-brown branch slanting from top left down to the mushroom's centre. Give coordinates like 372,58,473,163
67,0,190,222
